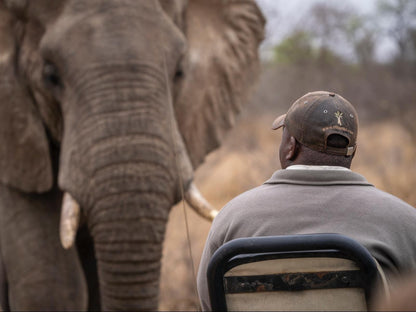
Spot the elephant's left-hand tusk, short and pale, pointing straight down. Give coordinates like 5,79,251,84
59,193,80,249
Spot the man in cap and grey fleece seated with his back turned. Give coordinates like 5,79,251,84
198,91,416,310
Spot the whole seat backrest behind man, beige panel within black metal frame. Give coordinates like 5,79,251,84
207,234,379,311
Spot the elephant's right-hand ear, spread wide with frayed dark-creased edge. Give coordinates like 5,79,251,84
175,0,265,168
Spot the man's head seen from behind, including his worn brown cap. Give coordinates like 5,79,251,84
272,91,358,168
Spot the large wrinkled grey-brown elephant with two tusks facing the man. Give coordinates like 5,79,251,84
0,0,265,311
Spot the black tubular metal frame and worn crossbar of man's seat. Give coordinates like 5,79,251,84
207,234,379,311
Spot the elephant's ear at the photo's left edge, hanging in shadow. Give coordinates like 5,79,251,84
0,1,53,192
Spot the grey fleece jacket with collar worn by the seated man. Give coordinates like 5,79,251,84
198,170,416,310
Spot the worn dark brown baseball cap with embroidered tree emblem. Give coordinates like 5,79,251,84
272,91,358,156
